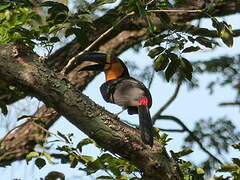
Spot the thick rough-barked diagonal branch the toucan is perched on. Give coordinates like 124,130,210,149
0,46,180,180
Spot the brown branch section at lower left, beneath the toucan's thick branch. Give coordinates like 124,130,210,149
0,106,60,164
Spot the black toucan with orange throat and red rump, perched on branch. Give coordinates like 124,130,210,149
77,52,153,147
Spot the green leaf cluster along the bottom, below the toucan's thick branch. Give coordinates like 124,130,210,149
34,132,139,179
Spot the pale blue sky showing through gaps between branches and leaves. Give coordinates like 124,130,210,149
0,10,240,180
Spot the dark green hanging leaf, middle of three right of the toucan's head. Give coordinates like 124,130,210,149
165,53,180,82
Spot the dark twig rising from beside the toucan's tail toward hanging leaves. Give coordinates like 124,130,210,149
152,77,183,124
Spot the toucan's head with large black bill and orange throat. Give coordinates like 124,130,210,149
78,53,129,81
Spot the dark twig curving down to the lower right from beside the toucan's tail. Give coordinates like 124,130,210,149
159,115,222,164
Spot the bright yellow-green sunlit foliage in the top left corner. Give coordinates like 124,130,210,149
0,1,39,45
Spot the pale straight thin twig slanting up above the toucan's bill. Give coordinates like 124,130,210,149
61,11,135,74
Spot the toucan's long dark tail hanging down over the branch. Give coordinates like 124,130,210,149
138,98,153,147
